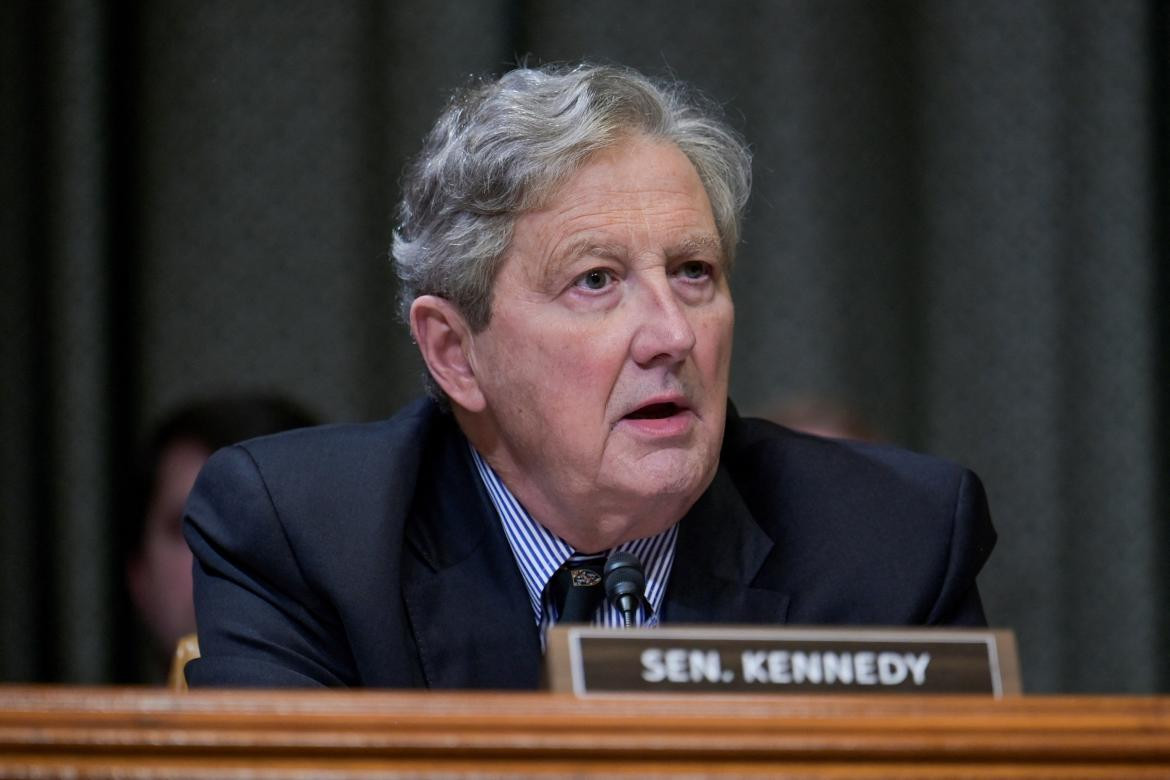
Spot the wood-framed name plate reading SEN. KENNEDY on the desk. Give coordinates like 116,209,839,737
545,626,1020,698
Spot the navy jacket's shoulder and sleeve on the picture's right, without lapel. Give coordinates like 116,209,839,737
682,412,996,626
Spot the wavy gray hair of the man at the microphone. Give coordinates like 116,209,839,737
392,64,751,331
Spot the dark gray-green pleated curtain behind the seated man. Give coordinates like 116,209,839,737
0,0,1170,691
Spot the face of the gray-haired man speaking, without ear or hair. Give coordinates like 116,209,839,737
461,137,735,551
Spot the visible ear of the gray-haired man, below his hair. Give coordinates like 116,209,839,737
411,295,486,412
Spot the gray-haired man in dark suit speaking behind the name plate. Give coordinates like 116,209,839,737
186,65,995,688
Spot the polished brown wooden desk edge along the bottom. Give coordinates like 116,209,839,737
0,686,1170,778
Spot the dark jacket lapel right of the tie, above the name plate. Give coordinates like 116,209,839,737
662,465,789,623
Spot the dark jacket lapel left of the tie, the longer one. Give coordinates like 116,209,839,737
402,419,541,689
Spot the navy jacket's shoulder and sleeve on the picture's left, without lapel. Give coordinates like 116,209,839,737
184,405,434,685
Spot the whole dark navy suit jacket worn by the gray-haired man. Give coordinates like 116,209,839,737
185,401,995,689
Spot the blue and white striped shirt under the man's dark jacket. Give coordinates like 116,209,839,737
468,444,679,647
